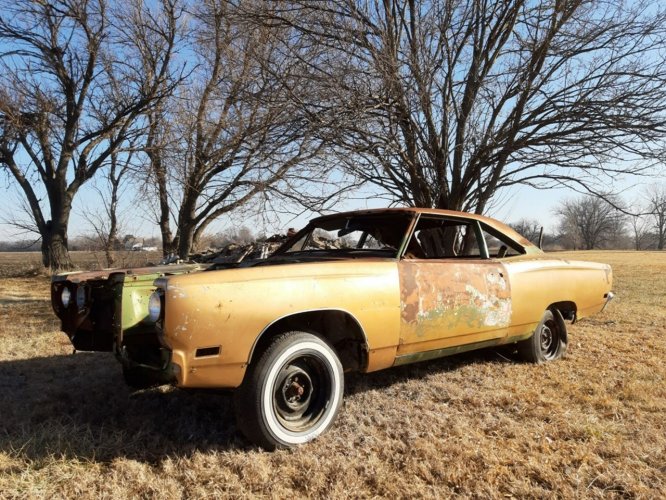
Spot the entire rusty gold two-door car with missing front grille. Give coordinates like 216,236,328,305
52,208,612,448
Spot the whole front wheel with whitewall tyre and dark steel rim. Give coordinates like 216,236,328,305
235,332,344,449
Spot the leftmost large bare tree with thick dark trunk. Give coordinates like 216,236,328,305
0,0,179,270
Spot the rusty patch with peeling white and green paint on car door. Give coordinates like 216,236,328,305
400,260,511,341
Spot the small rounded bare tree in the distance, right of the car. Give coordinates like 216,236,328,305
557,195,625,250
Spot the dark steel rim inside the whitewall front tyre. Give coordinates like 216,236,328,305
272,354,333,433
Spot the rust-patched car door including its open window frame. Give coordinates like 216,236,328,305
398,214,511,355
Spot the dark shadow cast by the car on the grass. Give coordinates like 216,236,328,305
0,350,510,463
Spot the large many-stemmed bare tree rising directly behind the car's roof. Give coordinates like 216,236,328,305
252,0,666,213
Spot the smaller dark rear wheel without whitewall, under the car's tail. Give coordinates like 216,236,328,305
518,309,567,363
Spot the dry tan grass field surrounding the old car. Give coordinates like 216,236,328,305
0,252,666,498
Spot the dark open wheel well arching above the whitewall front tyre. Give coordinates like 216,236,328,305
250,309,368,371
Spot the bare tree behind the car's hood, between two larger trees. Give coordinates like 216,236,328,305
144,1,323,258
